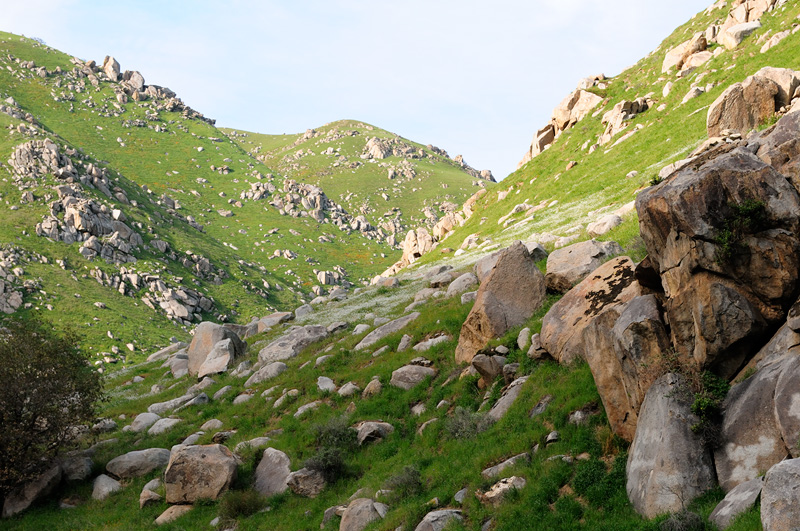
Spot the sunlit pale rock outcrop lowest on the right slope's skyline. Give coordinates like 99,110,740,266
517,79,605,169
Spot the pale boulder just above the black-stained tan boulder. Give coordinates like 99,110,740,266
545,240,622,293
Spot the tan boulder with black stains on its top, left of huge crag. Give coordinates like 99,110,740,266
540,255,642,363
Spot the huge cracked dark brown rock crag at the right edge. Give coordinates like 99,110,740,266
636,147,800,378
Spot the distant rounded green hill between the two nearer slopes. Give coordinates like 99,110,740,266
224,120,494,242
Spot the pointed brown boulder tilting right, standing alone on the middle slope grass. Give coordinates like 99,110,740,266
455,242,545,363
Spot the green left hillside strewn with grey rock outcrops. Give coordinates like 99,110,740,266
0,33,488,362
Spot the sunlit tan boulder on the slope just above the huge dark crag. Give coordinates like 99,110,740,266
706,76,778,137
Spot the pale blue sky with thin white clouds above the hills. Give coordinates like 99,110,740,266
0,0,712,179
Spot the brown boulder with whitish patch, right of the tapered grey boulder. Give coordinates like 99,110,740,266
714,358,797,492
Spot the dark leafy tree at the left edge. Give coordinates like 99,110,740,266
0,318,103,507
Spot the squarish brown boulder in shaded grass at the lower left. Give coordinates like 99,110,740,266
164,444,237,503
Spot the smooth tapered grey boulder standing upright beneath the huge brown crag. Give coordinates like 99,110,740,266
627,374,715,518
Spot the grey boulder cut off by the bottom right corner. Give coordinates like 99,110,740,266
761,459,800,531
